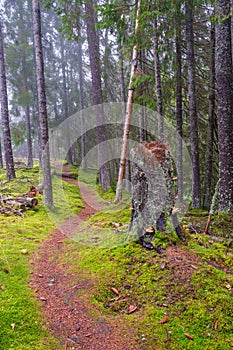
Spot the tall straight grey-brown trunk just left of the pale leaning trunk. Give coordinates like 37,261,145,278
85,0,110,191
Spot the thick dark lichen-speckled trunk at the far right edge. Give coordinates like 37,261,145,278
216,0,233,213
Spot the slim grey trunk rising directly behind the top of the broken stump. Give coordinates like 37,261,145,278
154,18,164,141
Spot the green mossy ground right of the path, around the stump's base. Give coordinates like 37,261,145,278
59,204,233,350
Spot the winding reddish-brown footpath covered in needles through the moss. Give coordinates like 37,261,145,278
30,173,138,350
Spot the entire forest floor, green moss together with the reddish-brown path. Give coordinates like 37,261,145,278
0,167,233,350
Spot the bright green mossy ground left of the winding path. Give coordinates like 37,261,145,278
0,166,82,350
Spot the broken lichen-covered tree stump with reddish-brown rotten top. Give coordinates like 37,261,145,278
130,141,183,249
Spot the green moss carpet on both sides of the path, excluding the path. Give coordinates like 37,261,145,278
0,165,233,350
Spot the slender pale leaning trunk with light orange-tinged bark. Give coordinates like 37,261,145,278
115,0,141,203
